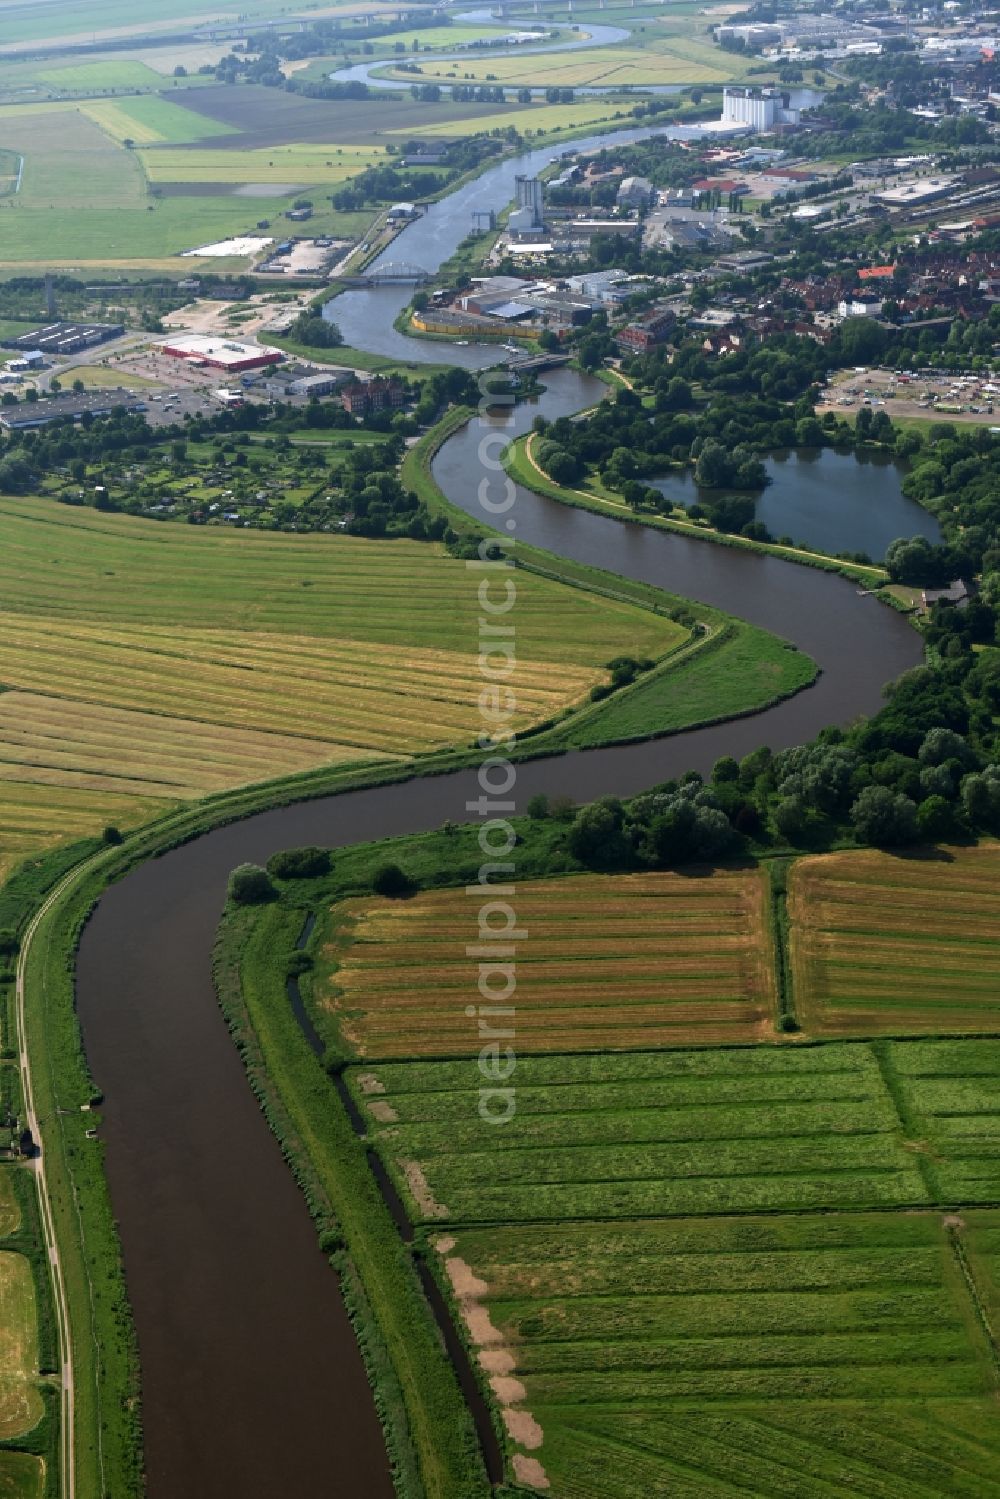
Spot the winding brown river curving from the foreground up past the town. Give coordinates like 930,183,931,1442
76,119,919,1499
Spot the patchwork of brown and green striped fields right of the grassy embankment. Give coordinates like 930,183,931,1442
312,844,1000,1499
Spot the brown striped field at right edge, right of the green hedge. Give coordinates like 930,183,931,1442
789,844,1000,1036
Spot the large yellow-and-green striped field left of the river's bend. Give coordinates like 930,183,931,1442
0,499,685,865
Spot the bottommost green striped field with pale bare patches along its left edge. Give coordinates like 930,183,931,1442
432,1213,1000,1499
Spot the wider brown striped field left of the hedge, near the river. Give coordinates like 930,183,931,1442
316,863,775,1058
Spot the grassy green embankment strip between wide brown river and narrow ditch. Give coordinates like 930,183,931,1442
216,904,490,1499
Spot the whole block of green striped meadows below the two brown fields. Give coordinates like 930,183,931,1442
348,1040,1000,1499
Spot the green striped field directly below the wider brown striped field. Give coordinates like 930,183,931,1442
351,1043,941,1223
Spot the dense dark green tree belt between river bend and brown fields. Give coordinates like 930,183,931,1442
548,644,1000,868
